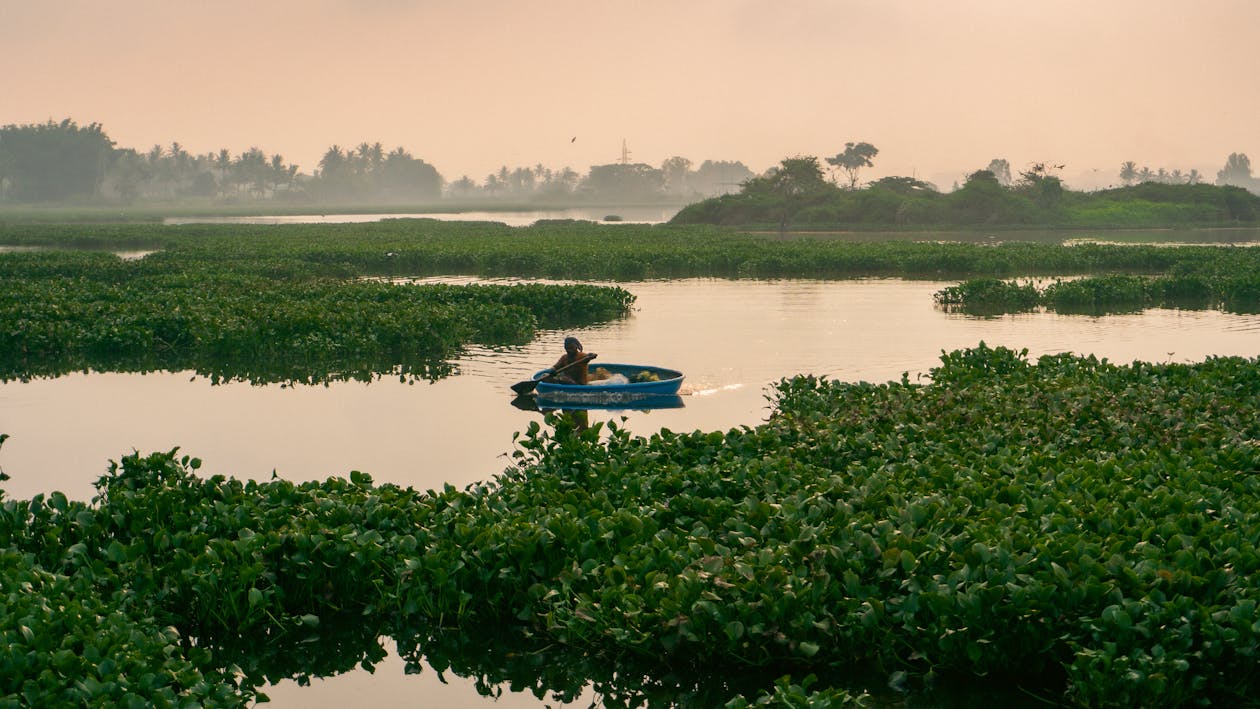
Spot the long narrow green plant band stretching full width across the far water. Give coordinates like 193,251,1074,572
7,219,1260,281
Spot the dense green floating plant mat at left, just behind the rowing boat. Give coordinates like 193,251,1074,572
0,252,634,383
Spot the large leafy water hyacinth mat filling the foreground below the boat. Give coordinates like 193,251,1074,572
0,344,1260,706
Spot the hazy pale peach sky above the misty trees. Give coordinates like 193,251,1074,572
0,0,1260,189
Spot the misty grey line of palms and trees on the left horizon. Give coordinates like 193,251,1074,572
0,118,753,204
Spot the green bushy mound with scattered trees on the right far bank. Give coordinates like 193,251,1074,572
673,144,1260,230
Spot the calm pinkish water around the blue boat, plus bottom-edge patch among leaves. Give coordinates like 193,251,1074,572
0,280,1260,708
